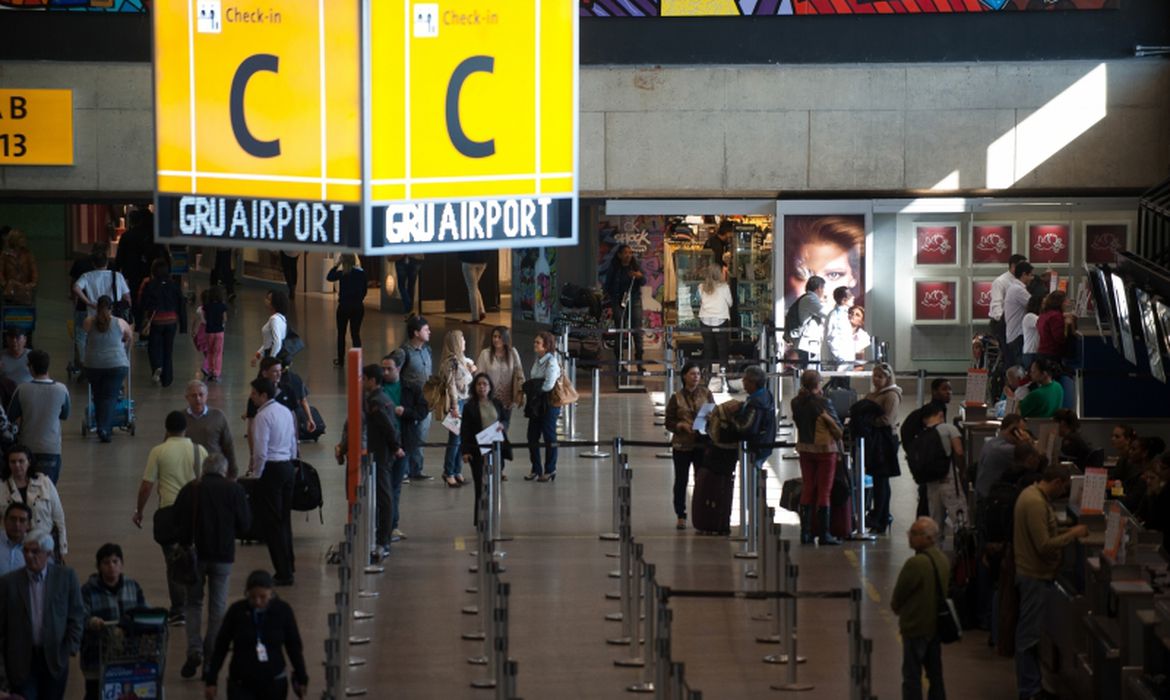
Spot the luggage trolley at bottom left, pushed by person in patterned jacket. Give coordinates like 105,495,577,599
98,608,167,700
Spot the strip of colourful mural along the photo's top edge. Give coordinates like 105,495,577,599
580,0,1121,18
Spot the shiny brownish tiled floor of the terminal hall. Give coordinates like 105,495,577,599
36,263,1014,700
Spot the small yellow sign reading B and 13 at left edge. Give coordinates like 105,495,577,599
0,89,74,165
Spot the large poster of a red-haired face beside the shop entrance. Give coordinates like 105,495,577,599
784,214,866,308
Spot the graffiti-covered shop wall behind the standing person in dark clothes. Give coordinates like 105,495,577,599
597,215,667,348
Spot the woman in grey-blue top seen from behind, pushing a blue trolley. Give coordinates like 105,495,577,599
84,295,135,442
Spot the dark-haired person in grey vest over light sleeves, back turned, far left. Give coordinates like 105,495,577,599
8,350,70,483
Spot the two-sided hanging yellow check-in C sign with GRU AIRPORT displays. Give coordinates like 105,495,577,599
153,0,578,255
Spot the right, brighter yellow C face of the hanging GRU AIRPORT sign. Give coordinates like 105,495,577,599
366,0,577,254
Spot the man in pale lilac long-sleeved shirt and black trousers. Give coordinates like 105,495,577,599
249,377,297,585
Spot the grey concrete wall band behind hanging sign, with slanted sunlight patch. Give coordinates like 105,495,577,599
0,59,1170,197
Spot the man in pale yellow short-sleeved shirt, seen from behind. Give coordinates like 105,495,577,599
132,411,207,625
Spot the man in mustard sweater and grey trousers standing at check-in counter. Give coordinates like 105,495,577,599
1012,462,1089,698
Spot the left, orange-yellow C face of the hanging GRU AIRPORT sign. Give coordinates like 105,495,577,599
154,0,362,249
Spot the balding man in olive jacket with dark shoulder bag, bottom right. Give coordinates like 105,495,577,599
889,517,950,700
